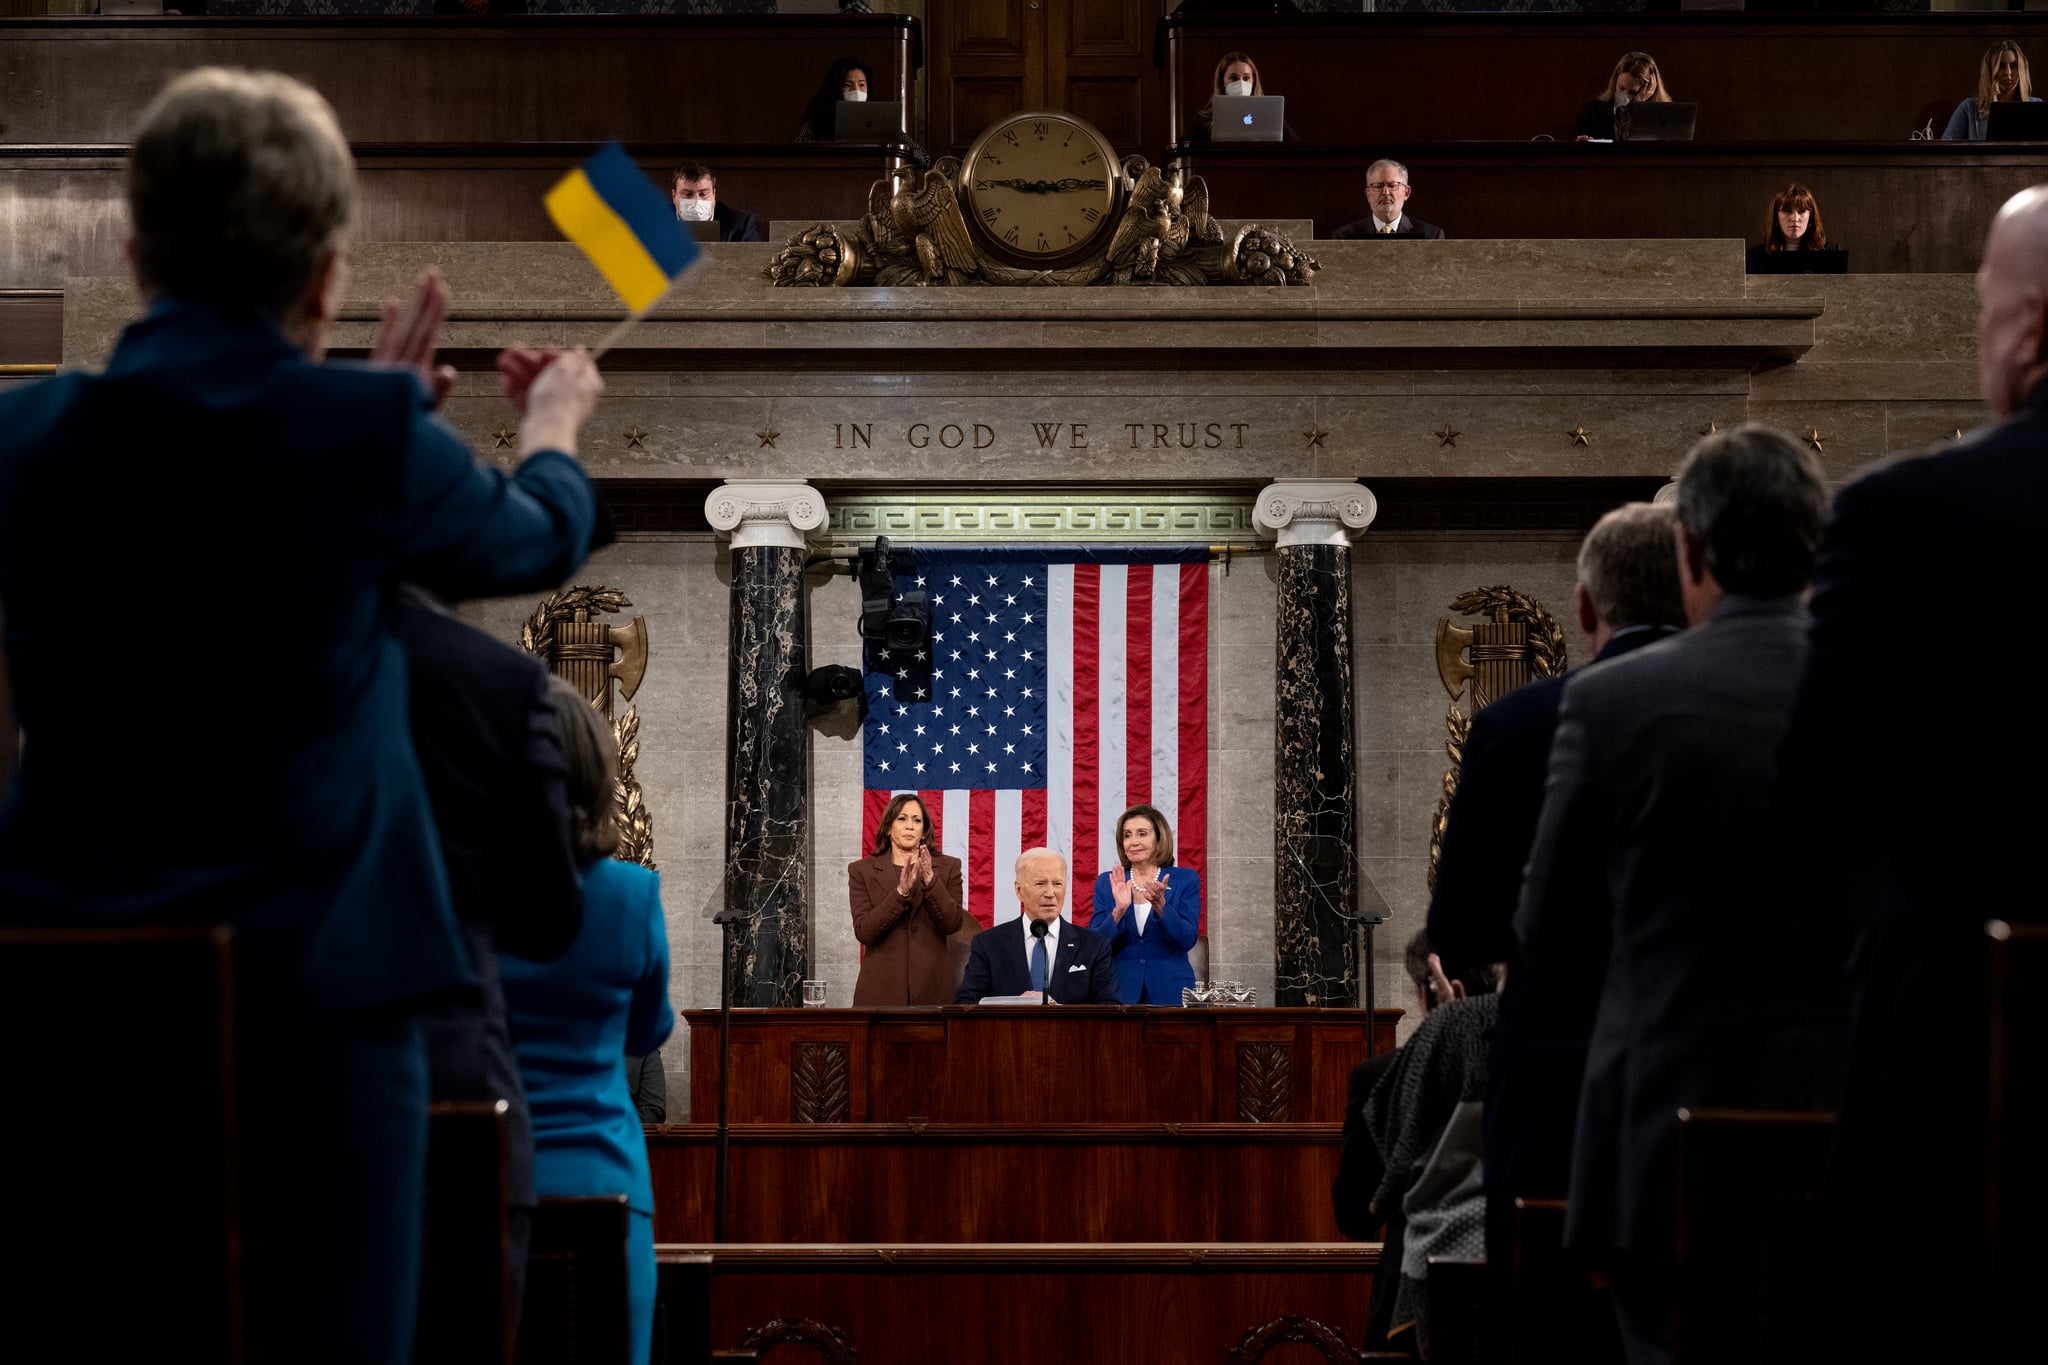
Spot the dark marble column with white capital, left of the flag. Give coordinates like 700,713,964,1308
705,483,825,1007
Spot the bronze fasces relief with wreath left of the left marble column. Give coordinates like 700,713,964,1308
520,583,655,868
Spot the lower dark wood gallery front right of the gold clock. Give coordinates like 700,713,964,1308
1176,143,2048,274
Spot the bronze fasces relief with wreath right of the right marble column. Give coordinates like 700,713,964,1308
1430,583,1565,890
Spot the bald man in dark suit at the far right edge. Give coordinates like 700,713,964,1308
1780,186,2048,1361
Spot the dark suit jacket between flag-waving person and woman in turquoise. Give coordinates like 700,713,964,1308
393,587,584,1205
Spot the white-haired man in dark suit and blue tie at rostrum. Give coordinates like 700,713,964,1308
952,849,1122,1005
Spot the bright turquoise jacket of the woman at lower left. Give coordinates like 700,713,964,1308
500,857,676,1218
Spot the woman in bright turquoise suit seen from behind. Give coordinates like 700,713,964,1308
504,677,676,1365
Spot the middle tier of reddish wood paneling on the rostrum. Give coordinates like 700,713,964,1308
647,1124,1341,1242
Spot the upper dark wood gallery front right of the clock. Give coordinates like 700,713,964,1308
1167,14,2048,143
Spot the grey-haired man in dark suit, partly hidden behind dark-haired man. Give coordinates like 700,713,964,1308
1430,503,1686,1265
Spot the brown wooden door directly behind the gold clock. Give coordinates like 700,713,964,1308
928,0,1169,160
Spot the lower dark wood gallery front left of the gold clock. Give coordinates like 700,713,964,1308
0,143,895,289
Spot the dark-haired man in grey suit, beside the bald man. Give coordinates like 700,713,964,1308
1516,426,1835,1365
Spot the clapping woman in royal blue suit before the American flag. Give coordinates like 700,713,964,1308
1087,806,1202,1005
